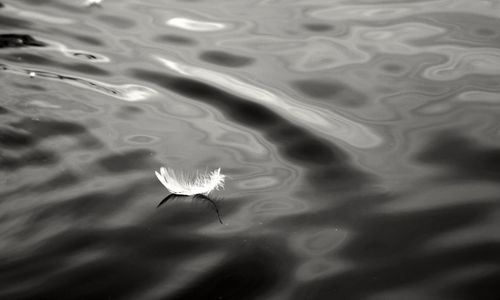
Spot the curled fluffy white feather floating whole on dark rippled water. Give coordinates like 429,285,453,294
155,167,226,196
